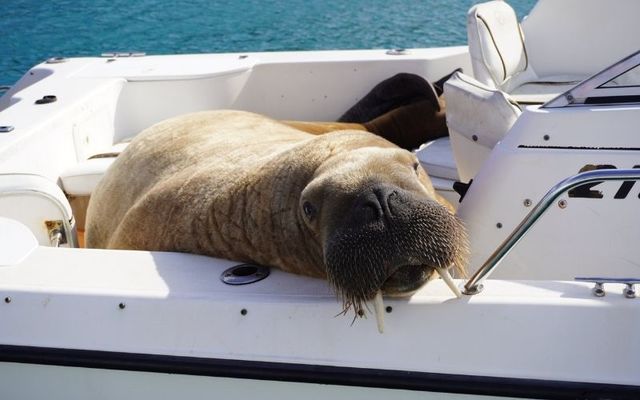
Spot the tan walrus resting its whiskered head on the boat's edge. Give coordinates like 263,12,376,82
86,110,467,328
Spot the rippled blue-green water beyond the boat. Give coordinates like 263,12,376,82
0,0,535,85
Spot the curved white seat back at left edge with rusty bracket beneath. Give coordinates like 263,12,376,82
0,174,76,246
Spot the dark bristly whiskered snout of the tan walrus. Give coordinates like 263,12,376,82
324,184,467,309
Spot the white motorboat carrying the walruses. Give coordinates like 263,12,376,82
0,0,640,400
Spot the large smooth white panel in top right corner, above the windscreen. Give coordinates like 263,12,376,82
522,0,640,80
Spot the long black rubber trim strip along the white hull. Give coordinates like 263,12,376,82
0,345,640,400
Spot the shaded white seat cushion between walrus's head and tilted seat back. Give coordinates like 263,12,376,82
415,137,460,207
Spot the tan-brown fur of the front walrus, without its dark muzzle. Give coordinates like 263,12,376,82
86,111,464,310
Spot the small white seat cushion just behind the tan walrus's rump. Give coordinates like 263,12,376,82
60,157,116,196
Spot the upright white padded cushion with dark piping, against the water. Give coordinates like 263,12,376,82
467,1,528,87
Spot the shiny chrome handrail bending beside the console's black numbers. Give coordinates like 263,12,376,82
462,169,640,295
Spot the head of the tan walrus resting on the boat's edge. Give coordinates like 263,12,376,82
299,147,467,315
